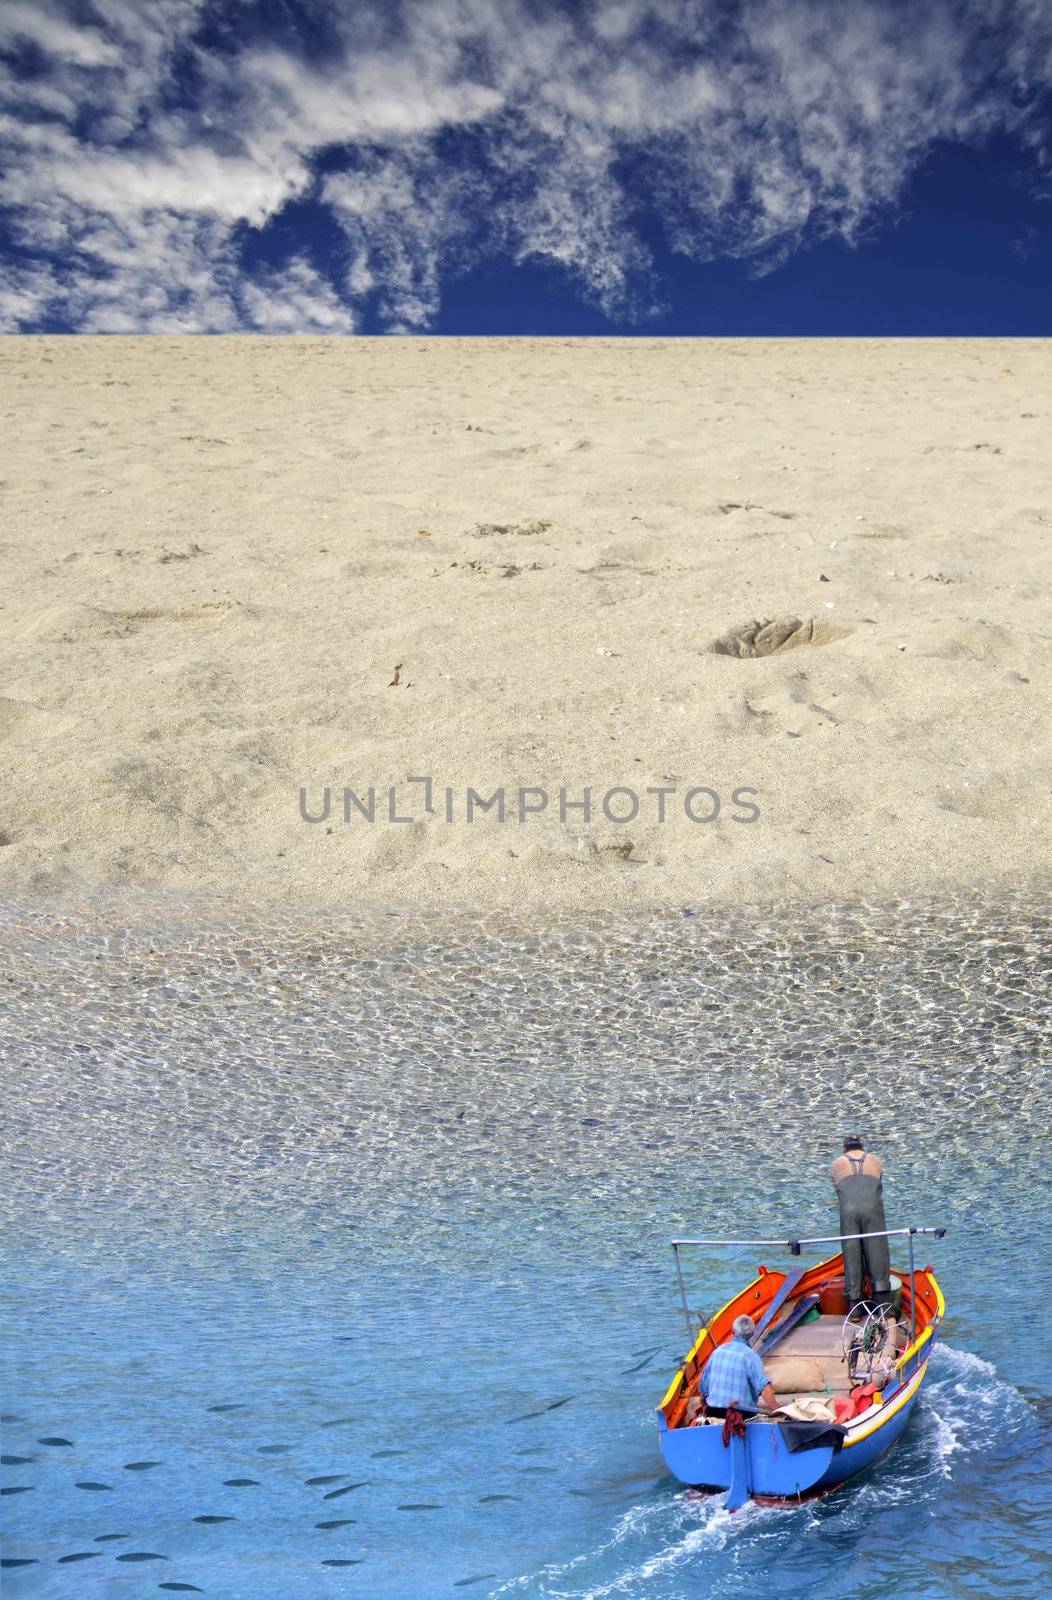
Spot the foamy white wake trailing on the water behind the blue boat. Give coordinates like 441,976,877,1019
491,1344,1033,1600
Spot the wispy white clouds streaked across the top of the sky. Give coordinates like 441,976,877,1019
0,0,1052,333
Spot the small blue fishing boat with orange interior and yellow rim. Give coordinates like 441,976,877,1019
657,1227,946,1510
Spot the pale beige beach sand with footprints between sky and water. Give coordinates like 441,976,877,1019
0,338,1052,914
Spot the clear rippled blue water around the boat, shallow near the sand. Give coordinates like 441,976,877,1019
0,902,1052,1600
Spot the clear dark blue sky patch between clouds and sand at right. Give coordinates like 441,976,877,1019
435,139,1052,338
